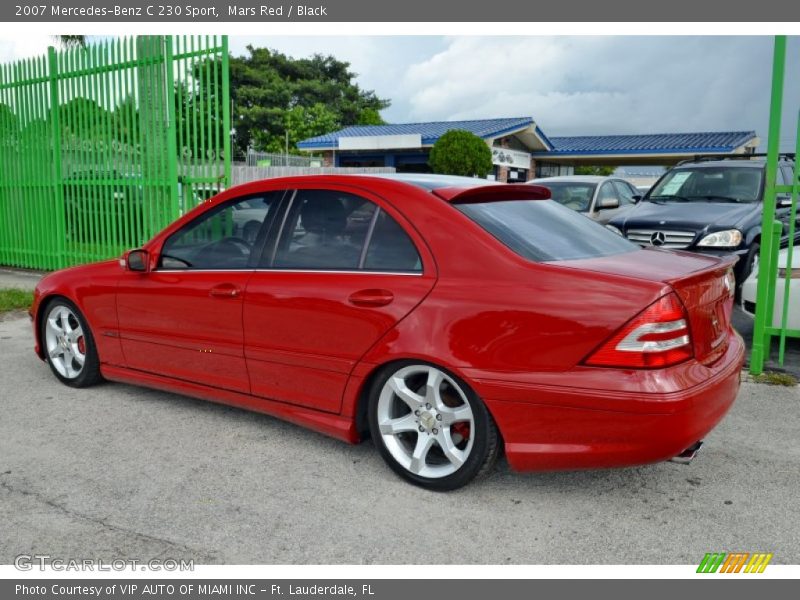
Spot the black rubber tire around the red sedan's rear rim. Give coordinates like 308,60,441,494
367,361,501,492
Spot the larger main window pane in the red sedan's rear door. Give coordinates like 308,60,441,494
272,190,377,270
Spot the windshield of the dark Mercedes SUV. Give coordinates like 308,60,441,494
647,167,763,202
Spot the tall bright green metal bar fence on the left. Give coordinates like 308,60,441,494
0,36,231,269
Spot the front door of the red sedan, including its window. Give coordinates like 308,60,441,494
117,192,283,392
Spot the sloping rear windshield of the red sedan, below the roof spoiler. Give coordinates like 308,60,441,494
454,200,639,262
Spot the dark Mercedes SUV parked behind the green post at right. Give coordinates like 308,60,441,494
607,155,800,287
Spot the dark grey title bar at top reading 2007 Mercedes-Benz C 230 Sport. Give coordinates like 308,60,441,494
0,0,800,21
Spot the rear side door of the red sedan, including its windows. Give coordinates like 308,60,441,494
243,186,435,412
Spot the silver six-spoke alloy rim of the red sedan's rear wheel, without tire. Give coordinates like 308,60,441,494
377,365,475,478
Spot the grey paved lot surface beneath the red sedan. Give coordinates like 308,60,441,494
0,318,800,564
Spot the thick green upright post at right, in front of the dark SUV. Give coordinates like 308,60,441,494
750,35,786,375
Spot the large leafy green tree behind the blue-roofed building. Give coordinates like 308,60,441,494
230,46,389,156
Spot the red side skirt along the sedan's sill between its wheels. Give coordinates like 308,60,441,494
100,365,361,444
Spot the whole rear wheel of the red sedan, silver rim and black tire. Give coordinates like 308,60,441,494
369,362,500,491
